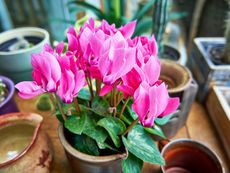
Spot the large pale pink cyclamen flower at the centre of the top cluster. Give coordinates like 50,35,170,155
98,31,136,85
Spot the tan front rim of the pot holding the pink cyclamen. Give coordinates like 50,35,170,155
58,124,128,163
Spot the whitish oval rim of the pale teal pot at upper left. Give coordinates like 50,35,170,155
0,27,49,56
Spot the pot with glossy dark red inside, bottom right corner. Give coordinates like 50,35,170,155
161,139,225,173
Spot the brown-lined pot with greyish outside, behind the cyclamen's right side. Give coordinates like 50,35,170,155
160,60,198,138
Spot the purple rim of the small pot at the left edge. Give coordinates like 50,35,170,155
0,75,15,108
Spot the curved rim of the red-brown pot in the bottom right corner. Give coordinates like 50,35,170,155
161,138,225,173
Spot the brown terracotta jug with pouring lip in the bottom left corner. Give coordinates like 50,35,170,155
0,112,52,173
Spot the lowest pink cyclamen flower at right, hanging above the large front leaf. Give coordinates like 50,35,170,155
132,82,179,127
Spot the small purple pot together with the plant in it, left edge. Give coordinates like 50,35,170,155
0,75,18,115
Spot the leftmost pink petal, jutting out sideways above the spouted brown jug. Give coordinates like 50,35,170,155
15,81,45,99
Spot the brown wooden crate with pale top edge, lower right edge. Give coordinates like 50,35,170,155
206,86,230,158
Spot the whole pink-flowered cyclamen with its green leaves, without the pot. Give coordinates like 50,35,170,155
15,19,179,172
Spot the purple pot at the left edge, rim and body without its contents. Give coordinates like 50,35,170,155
0,75,18,116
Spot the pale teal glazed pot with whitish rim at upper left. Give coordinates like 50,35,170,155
0,27,49,83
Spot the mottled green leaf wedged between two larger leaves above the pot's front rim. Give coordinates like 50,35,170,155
83,114,108,142
